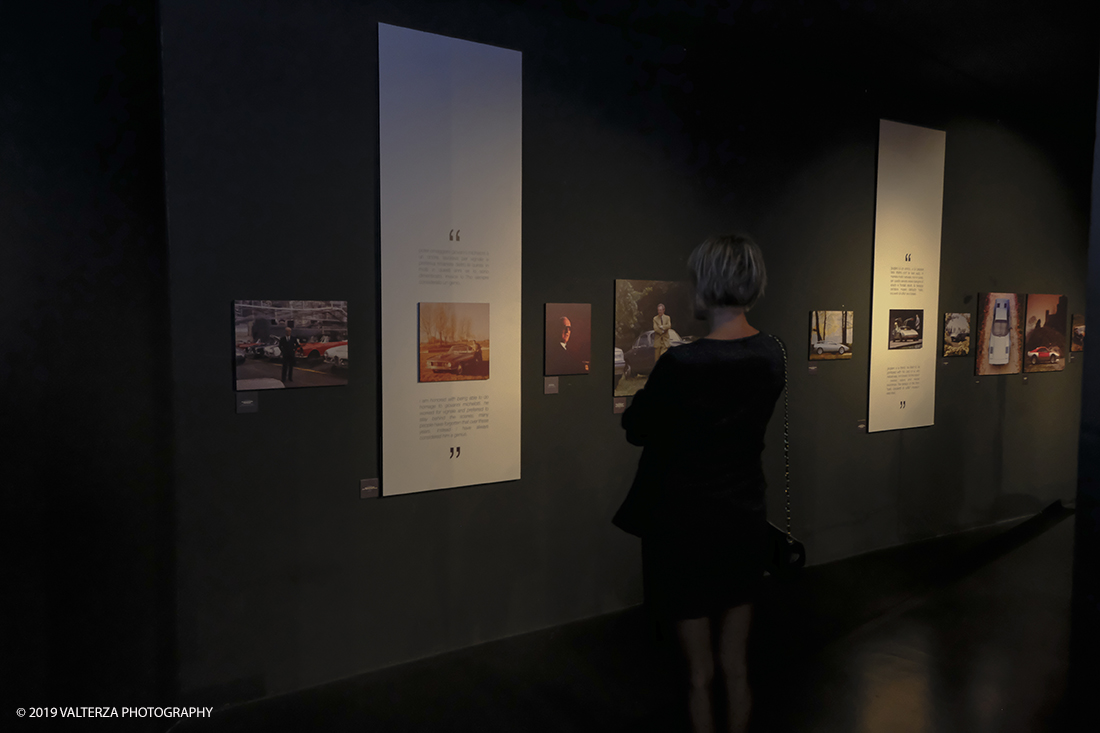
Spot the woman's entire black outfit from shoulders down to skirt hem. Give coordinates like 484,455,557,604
614,333,784,619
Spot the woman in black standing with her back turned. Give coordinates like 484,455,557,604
614,234,784,732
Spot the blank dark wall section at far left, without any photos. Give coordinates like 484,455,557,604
0,1,174,713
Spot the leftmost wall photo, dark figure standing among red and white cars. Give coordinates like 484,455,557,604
233,300,348,392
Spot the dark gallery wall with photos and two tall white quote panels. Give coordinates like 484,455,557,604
161,0,1097,703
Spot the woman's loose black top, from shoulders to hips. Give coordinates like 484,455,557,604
615,333,784,536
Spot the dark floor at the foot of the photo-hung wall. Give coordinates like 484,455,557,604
173,506,1073,733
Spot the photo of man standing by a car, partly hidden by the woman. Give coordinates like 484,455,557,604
614,280,707,397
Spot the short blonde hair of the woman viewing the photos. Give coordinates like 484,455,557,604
688,234,768,310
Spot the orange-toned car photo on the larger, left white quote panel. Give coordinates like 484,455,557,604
418,303,488,382
